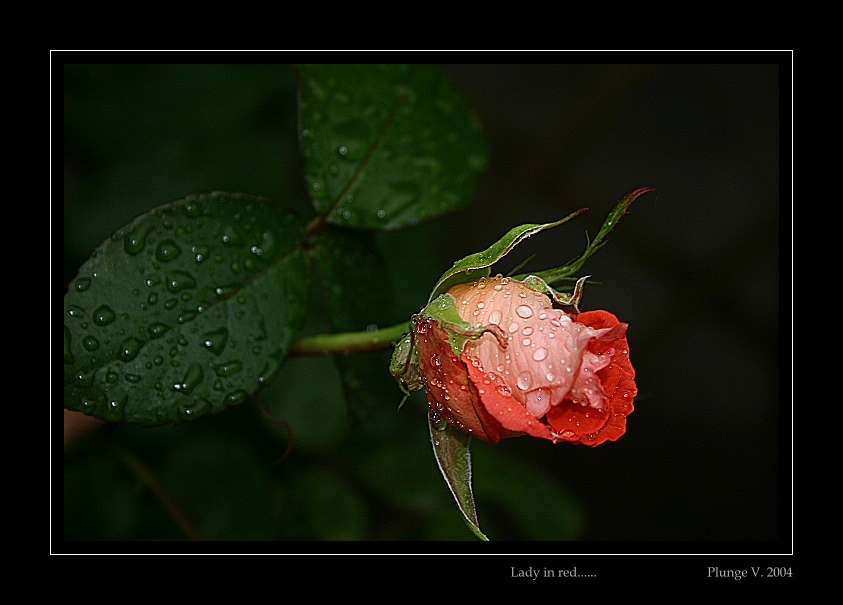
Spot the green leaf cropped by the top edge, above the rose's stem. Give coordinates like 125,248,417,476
297,65,487,229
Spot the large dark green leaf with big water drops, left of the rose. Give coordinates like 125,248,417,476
63,193,307,423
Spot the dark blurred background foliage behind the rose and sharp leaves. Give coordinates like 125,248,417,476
61,60,792,551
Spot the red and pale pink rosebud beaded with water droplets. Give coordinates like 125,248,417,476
406,276,637,446
